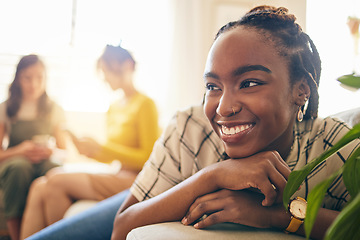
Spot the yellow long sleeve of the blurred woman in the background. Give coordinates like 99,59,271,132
95,100,159,170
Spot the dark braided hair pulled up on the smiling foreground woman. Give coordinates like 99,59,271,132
215,5,321,119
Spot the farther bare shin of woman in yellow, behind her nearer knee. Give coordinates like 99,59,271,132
20,177,47,239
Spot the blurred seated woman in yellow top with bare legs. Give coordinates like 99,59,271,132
21,45,160,238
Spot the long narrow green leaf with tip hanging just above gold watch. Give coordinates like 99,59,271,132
283,123,360,209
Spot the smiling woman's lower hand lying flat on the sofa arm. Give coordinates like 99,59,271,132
181,189,286,228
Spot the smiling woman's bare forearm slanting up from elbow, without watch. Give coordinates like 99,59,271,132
111,169,216,240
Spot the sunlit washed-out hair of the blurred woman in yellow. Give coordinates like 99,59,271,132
97,45,135,71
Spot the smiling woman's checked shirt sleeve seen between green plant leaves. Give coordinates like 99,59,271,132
288,118,360,211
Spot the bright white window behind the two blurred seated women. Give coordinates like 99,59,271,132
0,0,171,112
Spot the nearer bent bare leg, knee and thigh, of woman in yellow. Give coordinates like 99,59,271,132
45,173,98,225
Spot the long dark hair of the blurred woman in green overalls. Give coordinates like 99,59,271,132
6,54,52,119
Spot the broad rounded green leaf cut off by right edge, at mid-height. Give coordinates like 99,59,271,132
343,147,360,198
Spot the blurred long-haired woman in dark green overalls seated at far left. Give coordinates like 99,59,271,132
0,55,65,240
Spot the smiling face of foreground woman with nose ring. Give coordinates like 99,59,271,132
204,27,298,158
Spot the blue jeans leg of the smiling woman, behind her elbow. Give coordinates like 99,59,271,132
27,190,129,240
